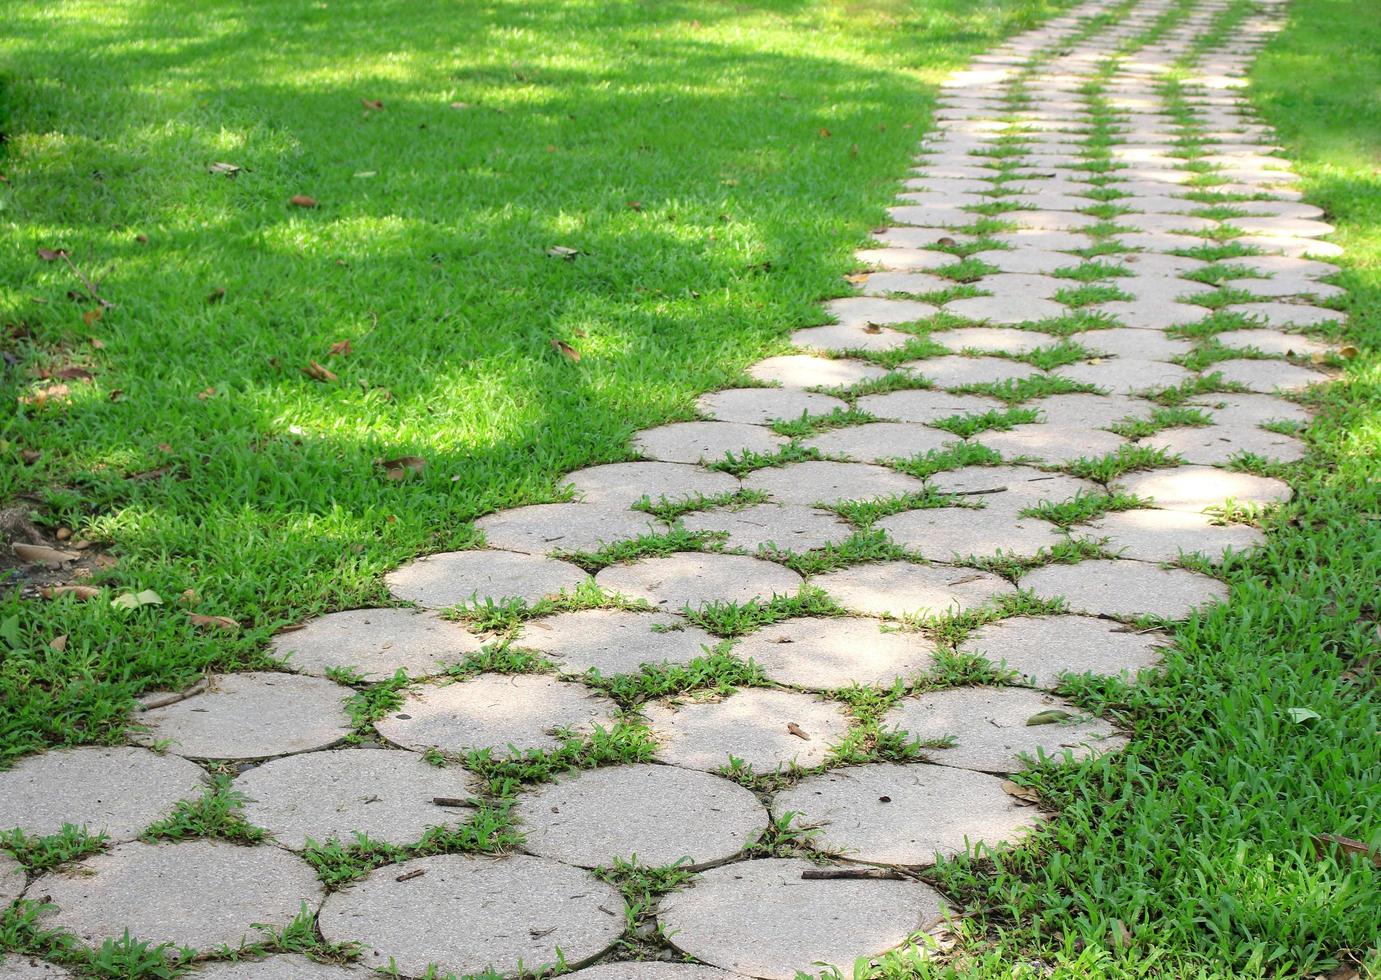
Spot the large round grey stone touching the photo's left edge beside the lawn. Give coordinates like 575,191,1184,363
0,747,206,839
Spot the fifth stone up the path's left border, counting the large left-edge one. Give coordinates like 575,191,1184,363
475,504,666,555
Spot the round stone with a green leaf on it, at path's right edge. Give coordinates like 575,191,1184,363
884,687,1127,773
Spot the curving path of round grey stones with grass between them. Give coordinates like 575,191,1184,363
0,0,1340,980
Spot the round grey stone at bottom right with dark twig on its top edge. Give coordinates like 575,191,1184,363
657,859,943,980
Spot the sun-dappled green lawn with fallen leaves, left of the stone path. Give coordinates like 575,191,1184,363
0,0,1062,758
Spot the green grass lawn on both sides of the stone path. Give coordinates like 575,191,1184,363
0,0,1381,979
